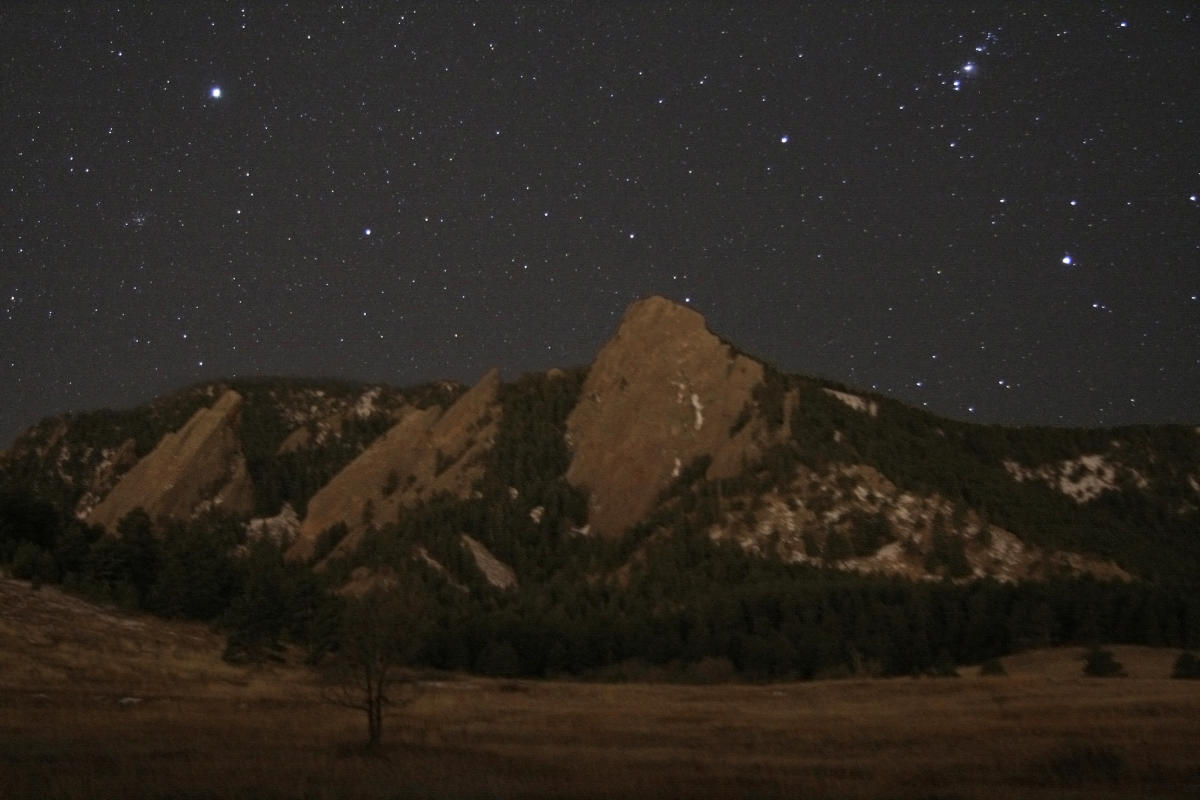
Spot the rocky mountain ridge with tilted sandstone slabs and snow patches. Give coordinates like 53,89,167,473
7,297,1200,587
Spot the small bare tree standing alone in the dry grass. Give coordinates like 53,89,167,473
324,587,424,748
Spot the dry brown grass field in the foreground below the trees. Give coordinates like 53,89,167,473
0,581,1200,800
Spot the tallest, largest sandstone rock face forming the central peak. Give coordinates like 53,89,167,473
566,297,763,536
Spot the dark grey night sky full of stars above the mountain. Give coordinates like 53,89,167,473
0,0,1200,446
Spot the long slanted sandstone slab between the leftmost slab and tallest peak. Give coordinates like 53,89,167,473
288,369,500,559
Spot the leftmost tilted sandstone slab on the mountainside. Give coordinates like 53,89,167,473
88,390,254,533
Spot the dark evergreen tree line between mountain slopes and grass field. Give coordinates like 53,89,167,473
0,482,1200,680
